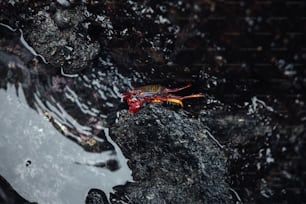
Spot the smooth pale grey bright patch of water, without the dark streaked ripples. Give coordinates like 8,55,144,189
0,85,132,203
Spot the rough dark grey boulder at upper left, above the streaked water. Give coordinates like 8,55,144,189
26,7,100,74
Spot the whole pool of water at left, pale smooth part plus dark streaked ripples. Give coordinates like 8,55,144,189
0,25,132,203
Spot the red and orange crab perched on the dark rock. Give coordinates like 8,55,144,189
123,84,204,113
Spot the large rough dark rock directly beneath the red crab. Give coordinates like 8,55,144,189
111,105,232,203
